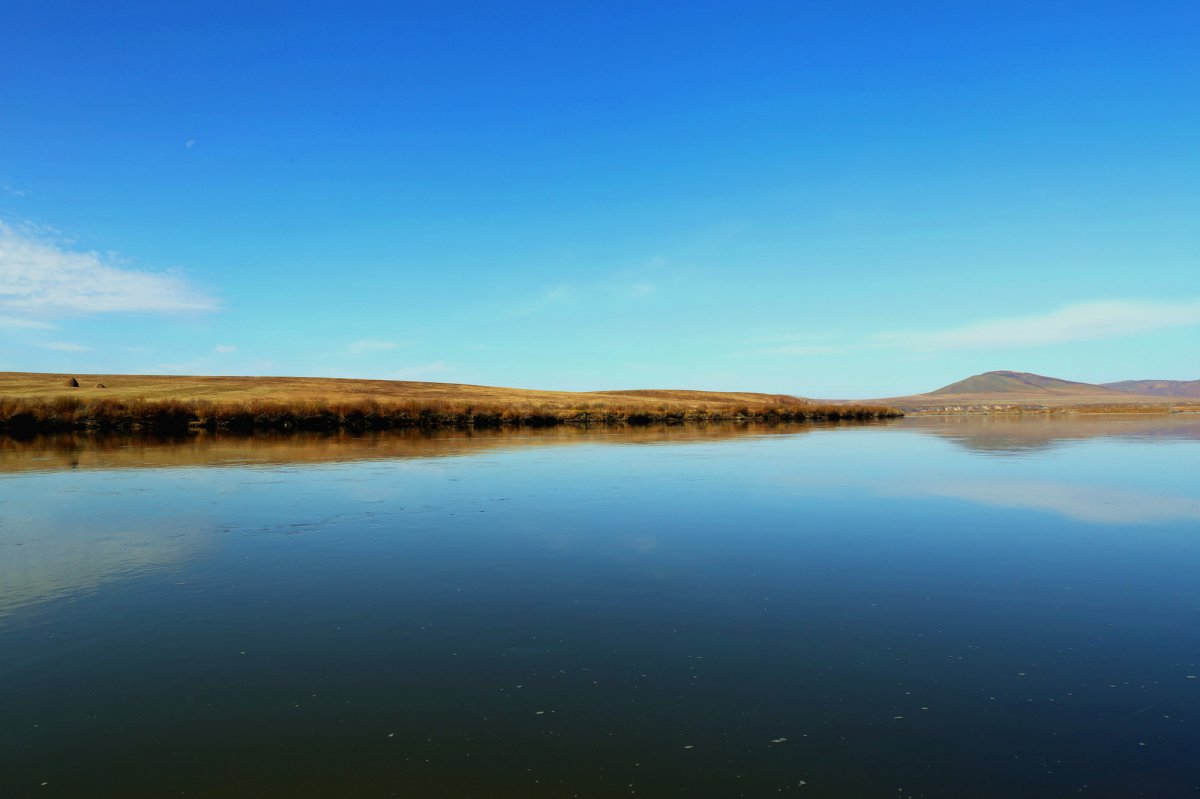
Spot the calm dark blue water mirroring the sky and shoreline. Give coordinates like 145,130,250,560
0,414,1200,799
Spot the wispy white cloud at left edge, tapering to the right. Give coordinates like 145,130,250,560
0,222,217,322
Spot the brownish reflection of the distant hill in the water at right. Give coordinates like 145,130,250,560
896,414,1200,455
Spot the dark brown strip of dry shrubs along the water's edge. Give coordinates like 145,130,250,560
0,397,902,433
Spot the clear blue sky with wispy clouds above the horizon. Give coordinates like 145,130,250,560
0,0,1200,397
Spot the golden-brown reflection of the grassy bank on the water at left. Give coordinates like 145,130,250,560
0,422,863,473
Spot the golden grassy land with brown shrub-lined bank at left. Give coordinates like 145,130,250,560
0,373,899,432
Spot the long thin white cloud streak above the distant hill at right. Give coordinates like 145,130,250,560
871,300,1200,350
